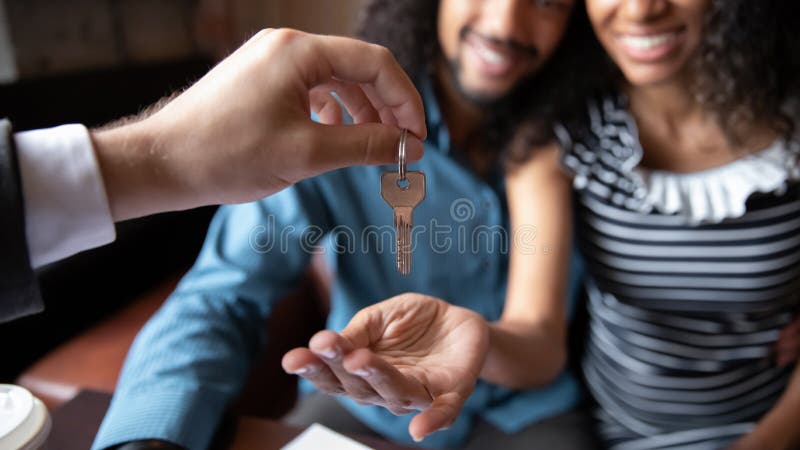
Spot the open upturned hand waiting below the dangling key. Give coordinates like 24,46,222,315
283,294,489,441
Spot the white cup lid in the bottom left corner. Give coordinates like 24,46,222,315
0,384,51,450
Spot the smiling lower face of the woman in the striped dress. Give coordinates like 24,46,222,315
586,0,708,86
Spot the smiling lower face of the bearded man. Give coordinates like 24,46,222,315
438,0,576,104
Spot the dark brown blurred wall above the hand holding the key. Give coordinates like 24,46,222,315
0,0,363,82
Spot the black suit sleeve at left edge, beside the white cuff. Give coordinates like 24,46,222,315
0,119,44,322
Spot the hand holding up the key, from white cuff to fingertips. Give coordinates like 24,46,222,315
92,29,426,220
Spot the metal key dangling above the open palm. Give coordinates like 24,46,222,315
381,171,425,275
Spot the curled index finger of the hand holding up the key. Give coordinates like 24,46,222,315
306,36,427,139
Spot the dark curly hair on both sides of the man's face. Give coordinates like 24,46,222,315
358,0,611,165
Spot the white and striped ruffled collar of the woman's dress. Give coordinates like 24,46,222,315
571,96,800,224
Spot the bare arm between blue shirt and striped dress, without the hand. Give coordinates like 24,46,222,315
480,144,572,388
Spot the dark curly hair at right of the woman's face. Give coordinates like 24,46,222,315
692,0,800,144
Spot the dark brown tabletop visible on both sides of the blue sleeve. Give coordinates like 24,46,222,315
46,390,410,450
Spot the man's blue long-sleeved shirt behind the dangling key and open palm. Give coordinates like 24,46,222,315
93,81,581,449
